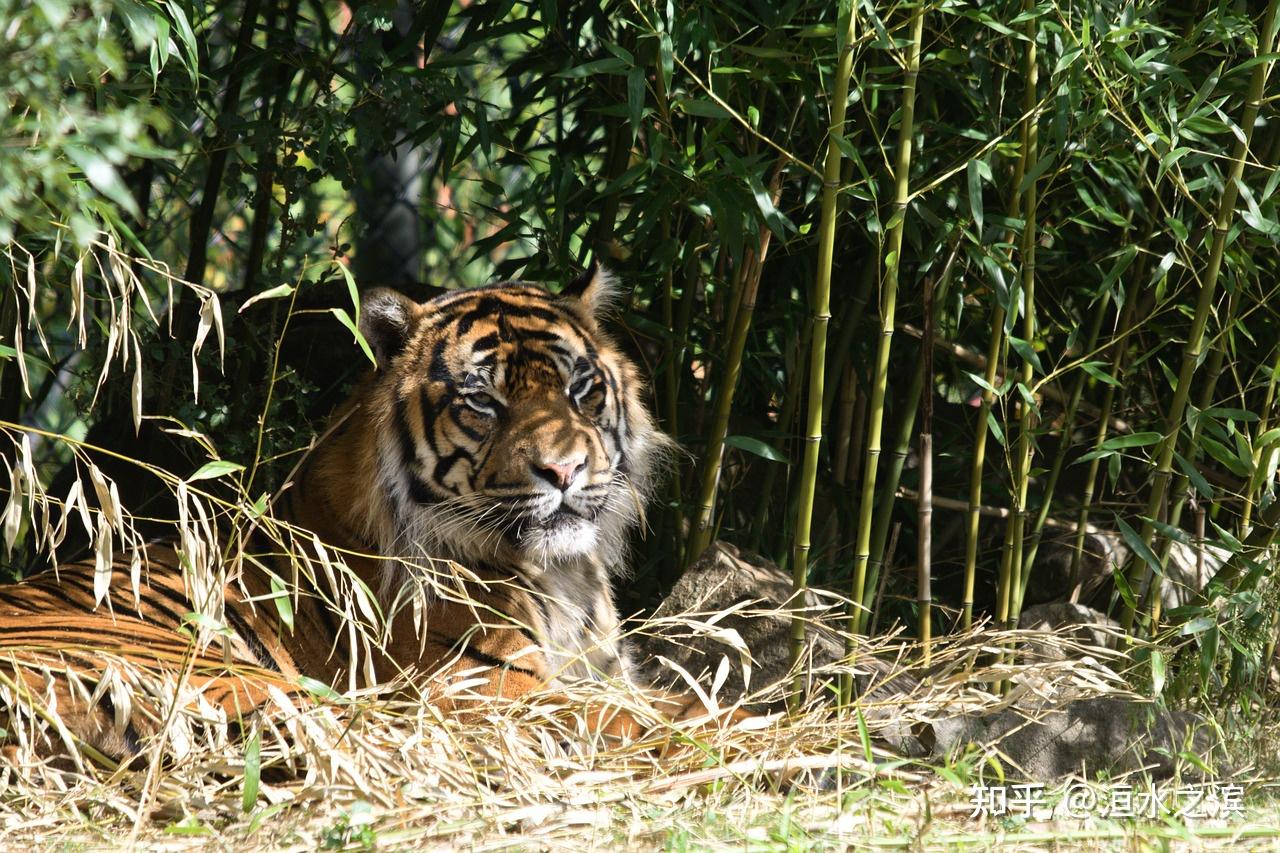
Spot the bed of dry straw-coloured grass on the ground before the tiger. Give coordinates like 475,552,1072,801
0,591,1172,849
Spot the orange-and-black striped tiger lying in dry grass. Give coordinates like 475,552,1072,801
0,266,732,760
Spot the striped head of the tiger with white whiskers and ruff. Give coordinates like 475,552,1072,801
350,270,668,569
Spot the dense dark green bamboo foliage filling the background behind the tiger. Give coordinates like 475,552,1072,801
0,0,1280,712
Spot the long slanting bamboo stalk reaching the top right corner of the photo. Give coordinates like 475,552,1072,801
1121,0,1280,631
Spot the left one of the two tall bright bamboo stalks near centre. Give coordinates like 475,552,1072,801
790,6,858,710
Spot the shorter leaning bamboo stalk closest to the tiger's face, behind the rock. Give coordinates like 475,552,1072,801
685,166,786,566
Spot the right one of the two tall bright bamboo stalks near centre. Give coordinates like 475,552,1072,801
841,5,924,666
